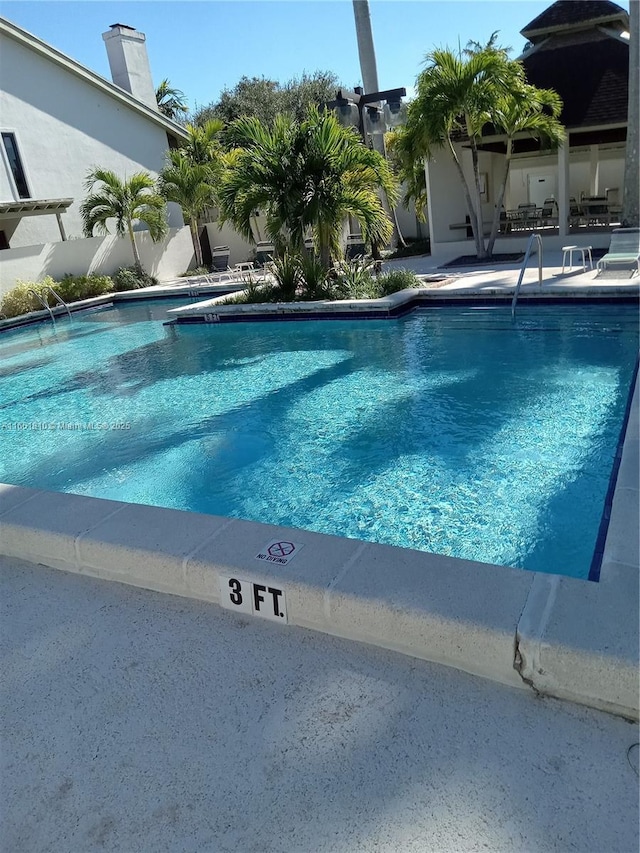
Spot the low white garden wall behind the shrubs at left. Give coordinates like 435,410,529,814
0,226,194,297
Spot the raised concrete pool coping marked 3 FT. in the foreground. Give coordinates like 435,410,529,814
0,376,640,720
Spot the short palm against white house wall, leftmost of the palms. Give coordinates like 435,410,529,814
80,169,167,273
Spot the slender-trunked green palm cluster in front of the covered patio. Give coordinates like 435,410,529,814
396,38,563,258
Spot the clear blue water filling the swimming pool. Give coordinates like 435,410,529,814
0,300,638,577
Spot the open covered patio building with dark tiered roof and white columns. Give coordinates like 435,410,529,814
426,0,629,254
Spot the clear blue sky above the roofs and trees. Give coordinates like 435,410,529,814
0,0,629,115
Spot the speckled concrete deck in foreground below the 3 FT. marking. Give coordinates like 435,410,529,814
0,558,638,853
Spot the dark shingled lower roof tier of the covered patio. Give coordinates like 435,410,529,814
522,35,629,128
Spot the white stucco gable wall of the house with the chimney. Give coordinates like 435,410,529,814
0,35,182,248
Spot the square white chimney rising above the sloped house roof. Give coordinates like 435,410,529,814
102,24,158,110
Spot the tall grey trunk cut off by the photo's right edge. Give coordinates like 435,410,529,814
622,0,640,228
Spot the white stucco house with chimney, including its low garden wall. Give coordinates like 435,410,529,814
0,18,190,290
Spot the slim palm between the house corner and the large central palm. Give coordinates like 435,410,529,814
158,149,216,267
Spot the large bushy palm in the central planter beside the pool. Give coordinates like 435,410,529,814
219,107,397,269
